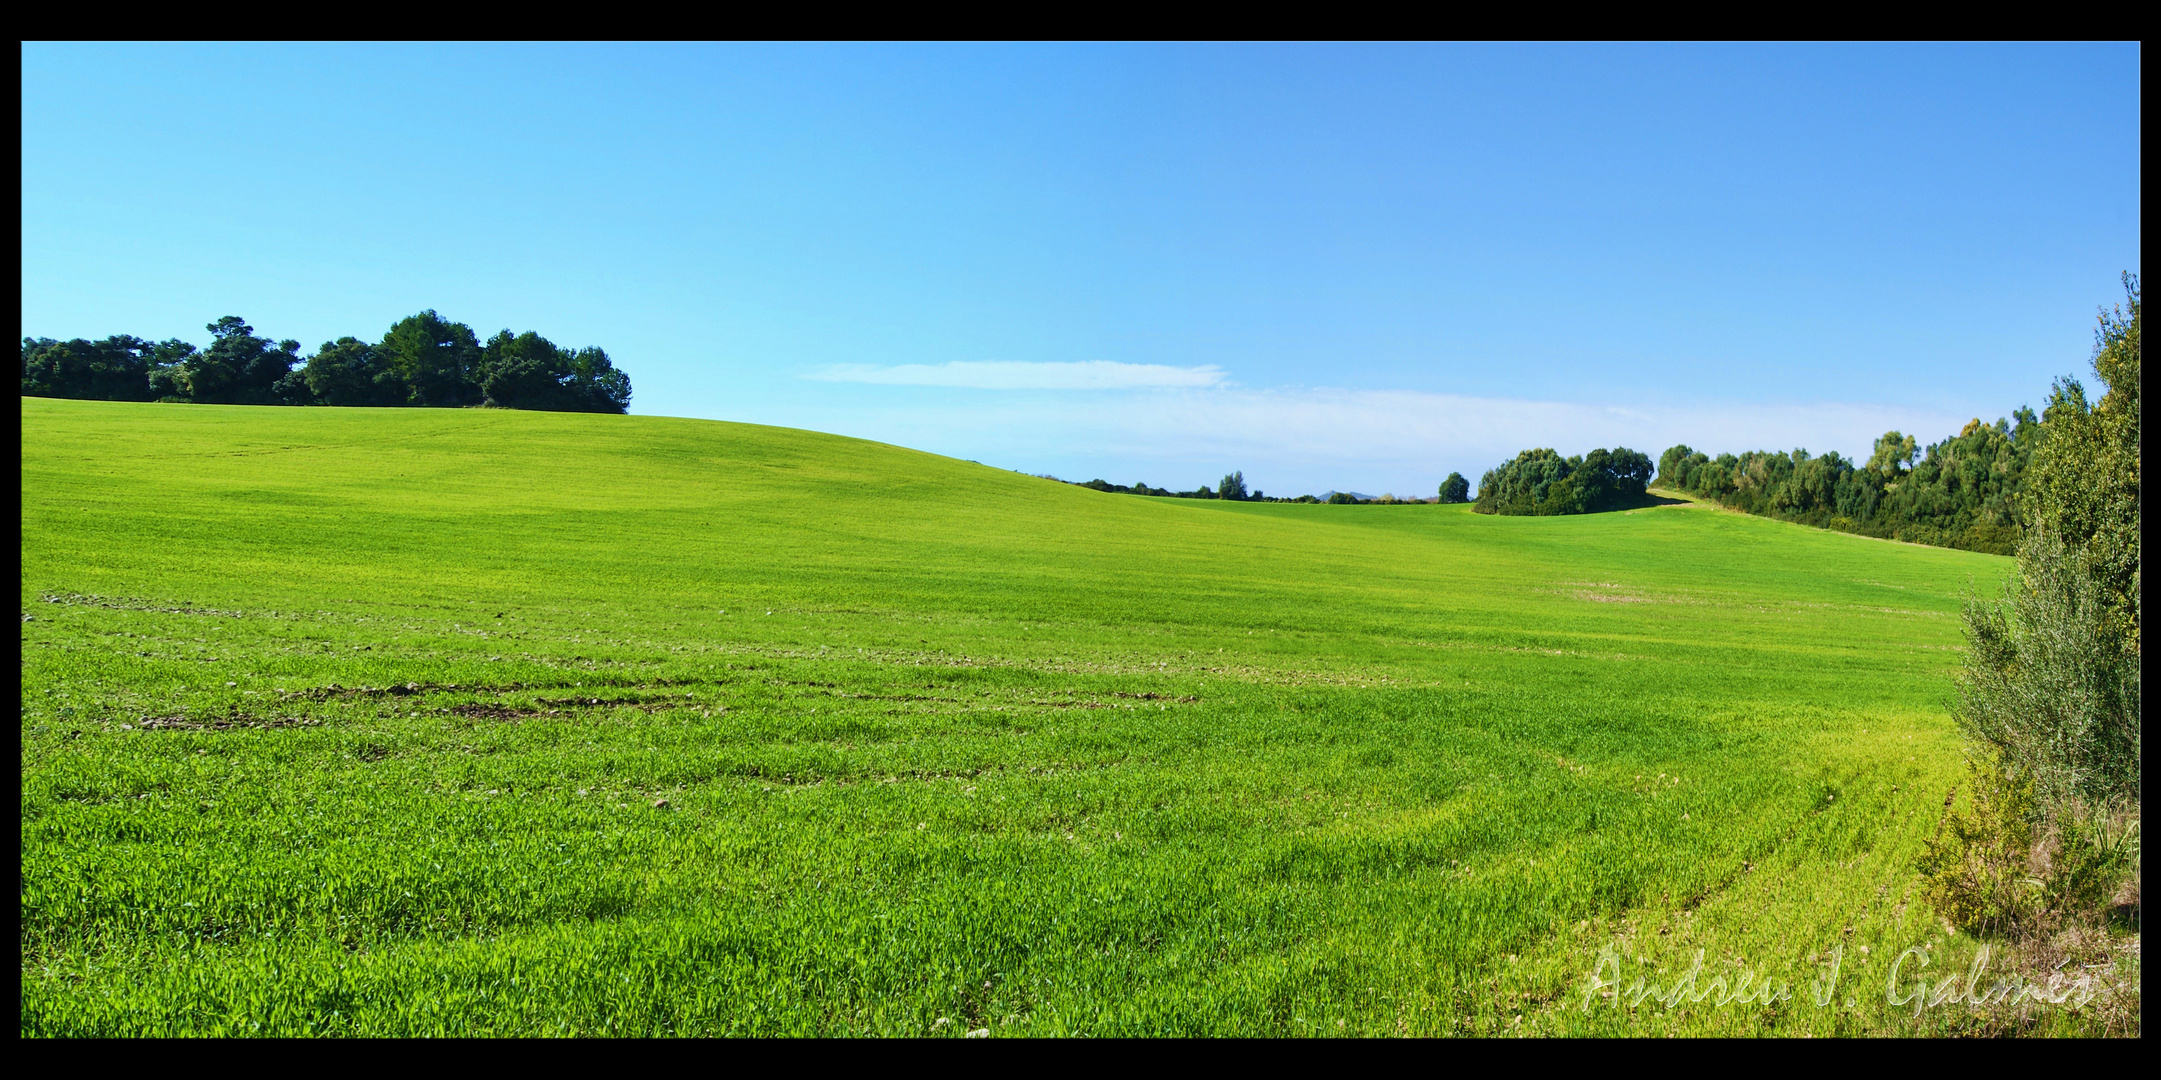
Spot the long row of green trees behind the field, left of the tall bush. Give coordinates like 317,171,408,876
1657,408,2039,555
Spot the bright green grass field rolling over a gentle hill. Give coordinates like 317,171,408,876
19,400,2074,1037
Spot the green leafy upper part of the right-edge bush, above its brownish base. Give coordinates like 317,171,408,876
1958,276,2139,808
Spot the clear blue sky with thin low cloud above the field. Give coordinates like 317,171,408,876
22,43,2139,495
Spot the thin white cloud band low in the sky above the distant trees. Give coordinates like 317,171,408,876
773,382,1995,495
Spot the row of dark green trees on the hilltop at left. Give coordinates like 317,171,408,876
22,311,631,413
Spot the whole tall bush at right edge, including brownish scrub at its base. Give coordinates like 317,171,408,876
1919,274,2142,937
